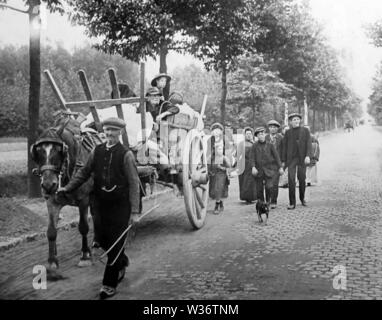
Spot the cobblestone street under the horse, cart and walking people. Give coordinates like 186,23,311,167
0,127,382,299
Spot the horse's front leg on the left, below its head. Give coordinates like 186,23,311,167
46,198,63,281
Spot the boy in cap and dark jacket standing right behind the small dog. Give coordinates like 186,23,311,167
250,127,284,203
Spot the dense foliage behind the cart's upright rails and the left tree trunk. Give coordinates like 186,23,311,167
0,45,139,136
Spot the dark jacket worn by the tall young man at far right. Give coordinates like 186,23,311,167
281,127,312,166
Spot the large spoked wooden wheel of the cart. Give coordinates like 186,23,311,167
182,129,208,229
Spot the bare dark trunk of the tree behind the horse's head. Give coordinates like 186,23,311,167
27,0,41,198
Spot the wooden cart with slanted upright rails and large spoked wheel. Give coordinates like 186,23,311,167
44,63,208,229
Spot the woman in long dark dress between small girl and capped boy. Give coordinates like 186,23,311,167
239,127,256,204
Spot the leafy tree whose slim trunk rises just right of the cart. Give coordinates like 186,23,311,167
187,0,264,125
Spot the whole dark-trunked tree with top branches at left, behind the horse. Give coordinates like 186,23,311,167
0,0,63,197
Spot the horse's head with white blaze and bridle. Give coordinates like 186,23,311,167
30,121,77,198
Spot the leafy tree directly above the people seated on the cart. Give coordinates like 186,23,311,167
68,0,209,95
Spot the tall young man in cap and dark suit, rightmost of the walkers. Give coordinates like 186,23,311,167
281,113,312,210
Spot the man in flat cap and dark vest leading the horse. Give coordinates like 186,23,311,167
58,118,139,299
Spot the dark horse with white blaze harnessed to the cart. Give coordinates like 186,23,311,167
30,115,102,281
